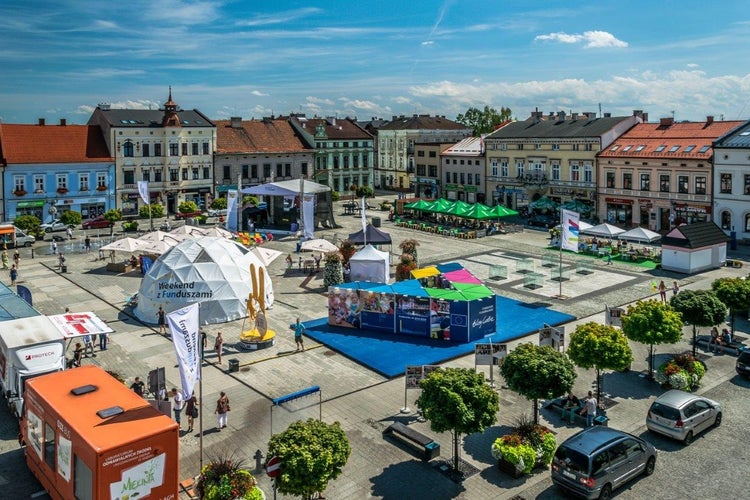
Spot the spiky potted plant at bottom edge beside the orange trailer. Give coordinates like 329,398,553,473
195,457,266,500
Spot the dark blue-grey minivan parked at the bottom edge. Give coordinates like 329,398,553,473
551,426,656,499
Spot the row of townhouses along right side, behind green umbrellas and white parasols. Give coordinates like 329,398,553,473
415,110,750,238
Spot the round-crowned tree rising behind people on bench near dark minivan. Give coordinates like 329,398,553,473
567,321,633,401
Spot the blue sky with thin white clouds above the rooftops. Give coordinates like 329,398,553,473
0,0,750,123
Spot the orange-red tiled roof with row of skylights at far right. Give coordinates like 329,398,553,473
598,121,745,159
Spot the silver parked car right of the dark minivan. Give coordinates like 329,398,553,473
646,389,721,445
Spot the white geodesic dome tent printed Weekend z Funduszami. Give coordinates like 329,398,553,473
134,236,273,325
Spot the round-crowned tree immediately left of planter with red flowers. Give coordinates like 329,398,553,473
622,300,683,379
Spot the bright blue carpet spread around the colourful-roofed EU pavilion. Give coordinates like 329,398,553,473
304,296,575,378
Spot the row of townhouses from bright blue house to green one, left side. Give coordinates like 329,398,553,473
0,90,382,220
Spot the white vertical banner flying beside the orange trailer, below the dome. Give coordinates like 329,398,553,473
167,303,201,400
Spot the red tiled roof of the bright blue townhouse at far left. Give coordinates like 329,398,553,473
0,124,113,164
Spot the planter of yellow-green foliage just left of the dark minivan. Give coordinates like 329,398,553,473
492,416,557,478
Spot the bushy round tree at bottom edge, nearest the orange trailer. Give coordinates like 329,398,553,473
268,419,352,499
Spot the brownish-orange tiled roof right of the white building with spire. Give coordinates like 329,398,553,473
214,119,313,153
